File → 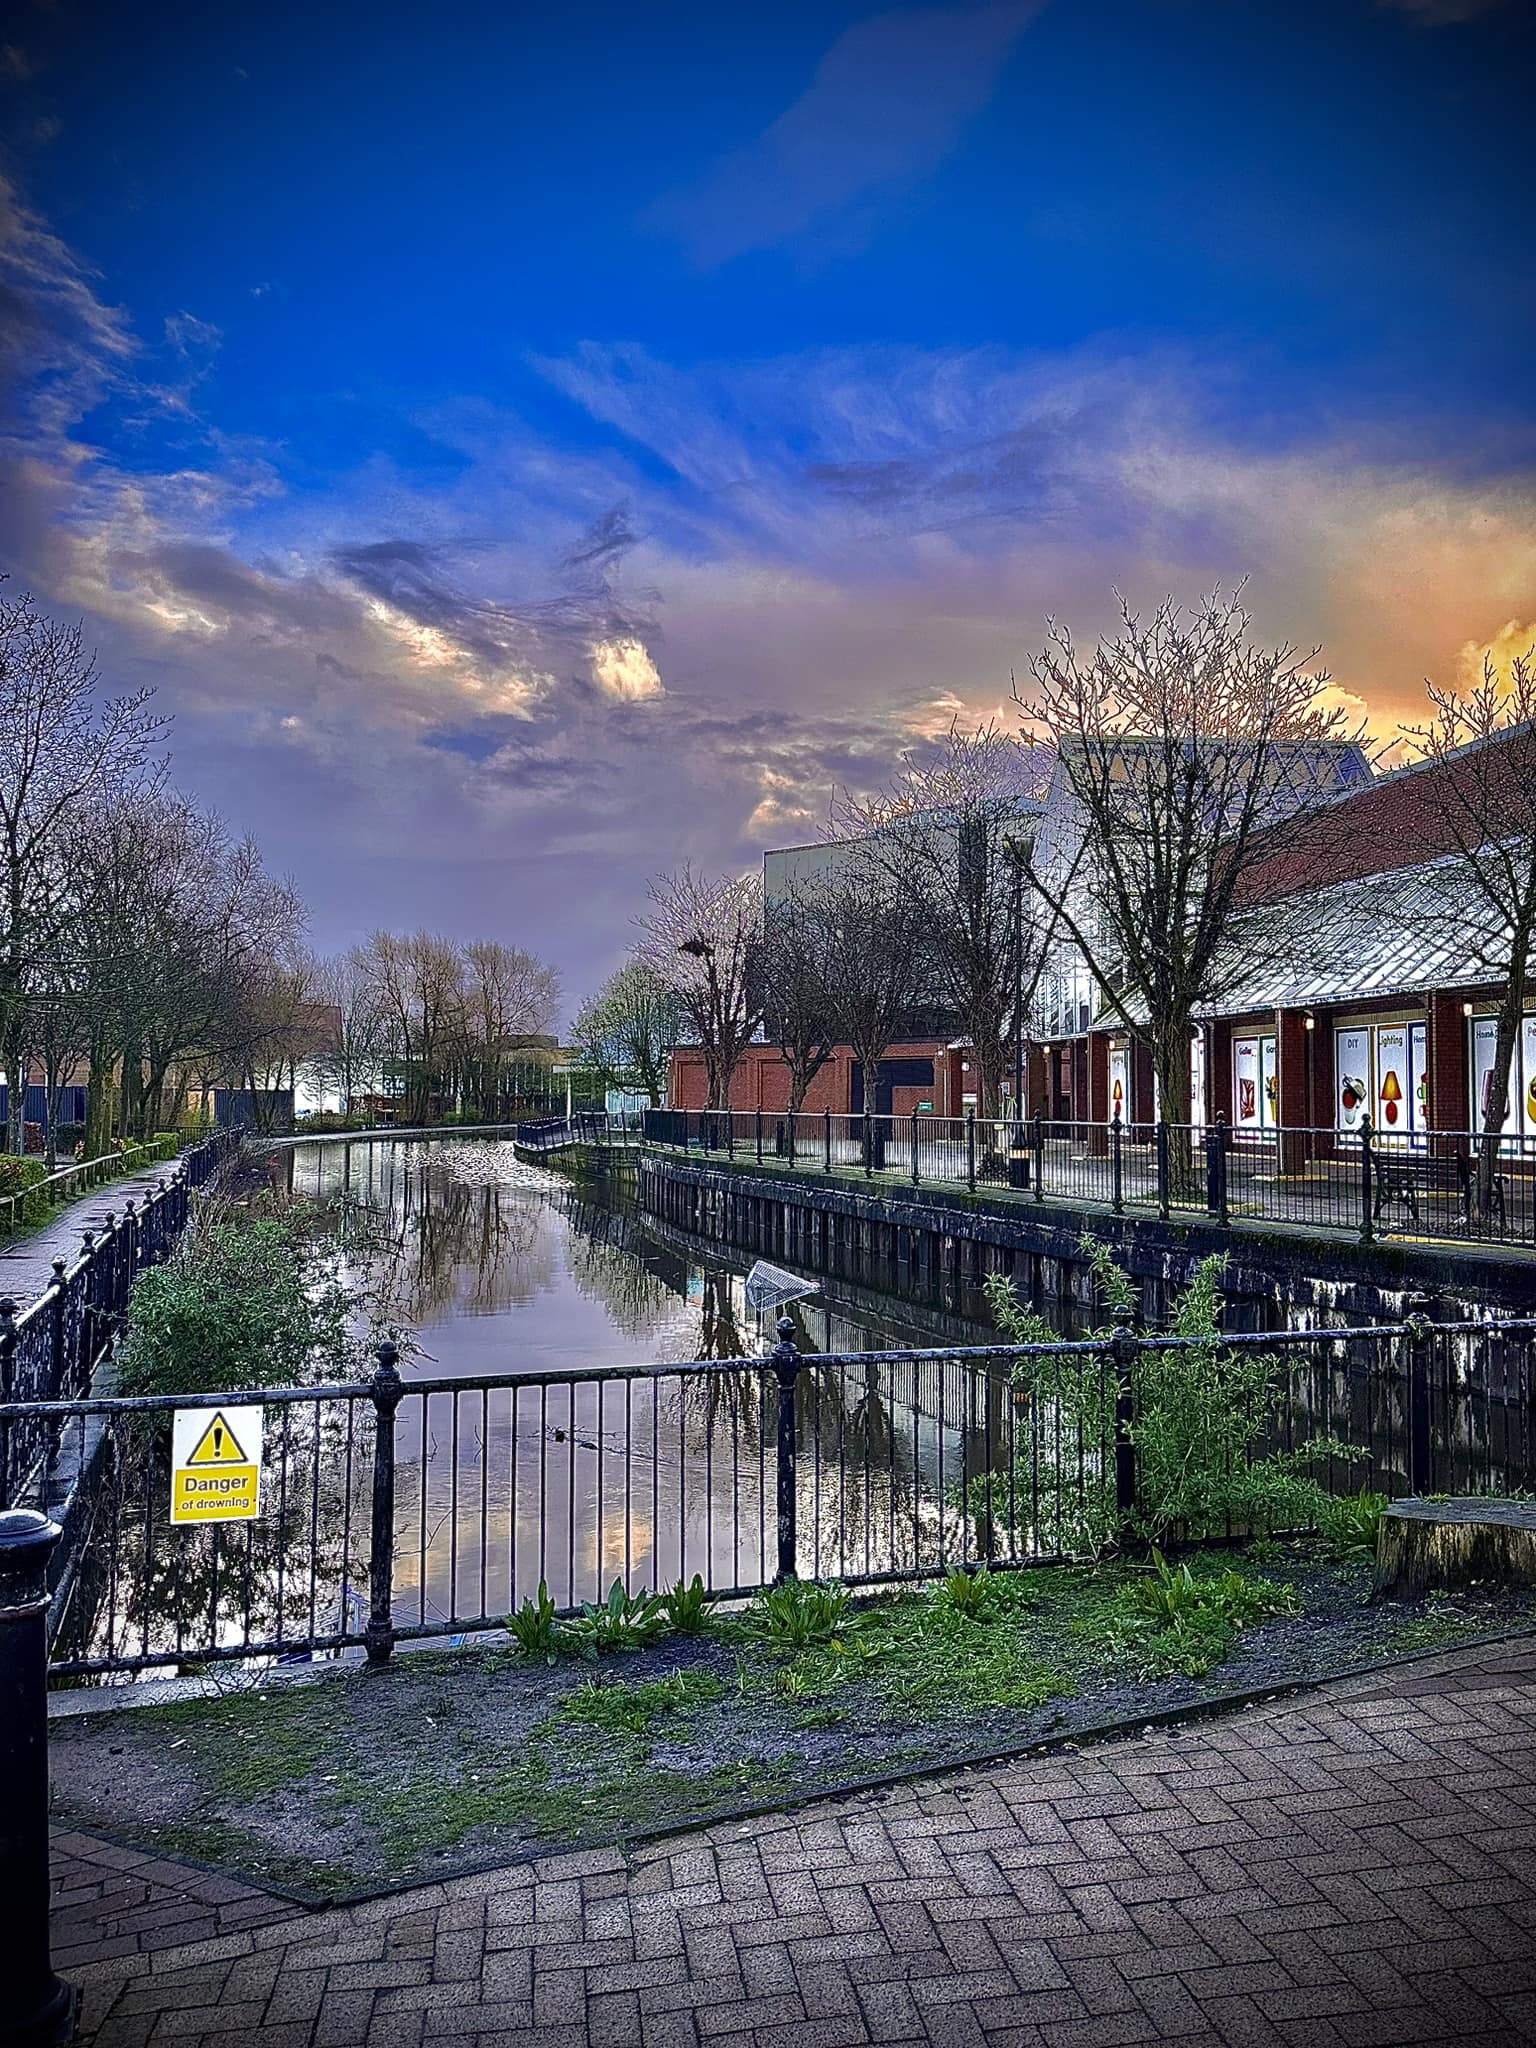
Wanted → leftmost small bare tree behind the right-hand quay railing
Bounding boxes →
[639,866,762,1110]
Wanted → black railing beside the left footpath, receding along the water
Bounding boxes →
[0,1130,240,1507]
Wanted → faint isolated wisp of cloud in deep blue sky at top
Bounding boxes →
[647,0,1042,266]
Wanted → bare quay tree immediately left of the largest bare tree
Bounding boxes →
[831,725,1051,1116]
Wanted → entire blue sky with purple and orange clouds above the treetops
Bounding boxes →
[0,0,1536,995]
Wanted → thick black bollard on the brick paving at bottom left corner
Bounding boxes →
[0,1507,76,2048]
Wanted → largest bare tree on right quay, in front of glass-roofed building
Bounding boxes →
[1018,590,1366,1171]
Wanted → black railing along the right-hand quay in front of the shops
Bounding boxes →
[643,1110,1536,1245]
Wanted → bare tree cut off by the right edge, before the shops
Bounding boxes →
[1405,643,1536,1219]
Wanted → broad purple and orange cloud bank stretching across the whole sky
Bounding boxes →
[0,174,1536,989]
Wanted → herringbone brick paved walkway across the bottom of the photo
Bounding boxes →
[55,1640,1536,2048]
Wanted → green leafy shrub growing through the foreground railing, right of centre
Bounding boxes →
[987,1235,1358,1554]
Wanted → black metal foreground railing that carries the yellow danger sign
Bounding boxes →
[12,1319,1536,1675]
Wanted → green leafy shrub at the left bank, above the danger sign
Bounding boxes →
[119,1202,369,1395]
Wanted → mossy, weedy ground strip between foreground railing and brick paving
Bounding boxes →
[53,1544,1536,1898]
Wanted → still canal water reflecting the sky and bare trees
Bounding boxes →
[279,1141,1028,1628]
